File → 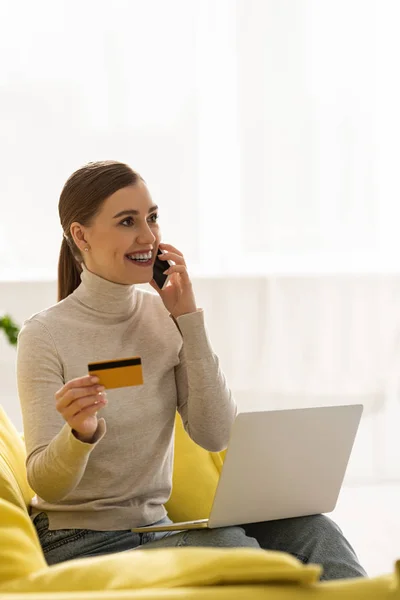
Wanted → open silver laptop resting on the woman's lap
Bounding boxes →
[132,404,363,532]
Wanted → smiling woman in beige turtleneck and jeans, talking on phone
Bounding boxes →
[17,161,365,579]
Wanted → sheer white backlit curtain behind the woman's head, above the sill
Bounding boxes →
[0,0,400,279]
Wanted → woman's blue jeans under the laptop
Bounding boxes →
[34,513,367,580]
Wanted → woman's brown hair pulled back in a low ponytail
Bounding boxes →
[58,160,142,301]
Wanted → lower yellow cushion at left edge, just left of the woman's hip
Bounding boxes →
[0,498,48,589]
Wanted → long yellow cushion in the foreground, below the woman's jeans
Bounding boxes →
[0,548,321,593]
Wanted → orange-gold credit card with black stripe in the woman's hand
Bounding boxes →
[88,356,143,389]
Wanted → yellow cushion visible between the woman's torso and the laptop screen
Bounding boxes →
[166,414,224,522]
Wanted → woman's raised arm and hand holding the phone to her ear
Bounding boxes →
[151,244,236,452]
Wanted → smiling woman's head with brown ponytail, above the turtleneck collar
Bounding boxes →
[58,161,161,300]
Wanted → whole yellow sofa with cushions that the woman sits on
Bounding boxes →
[0,407,400,600]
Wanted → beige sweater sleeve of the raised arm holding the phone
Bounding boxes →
[175,310,236,452]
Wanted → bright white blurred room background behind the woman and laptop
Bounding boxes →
[0,0,400,574]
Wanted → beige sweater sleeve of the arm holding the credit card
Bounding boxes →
[17,319,105,502]
